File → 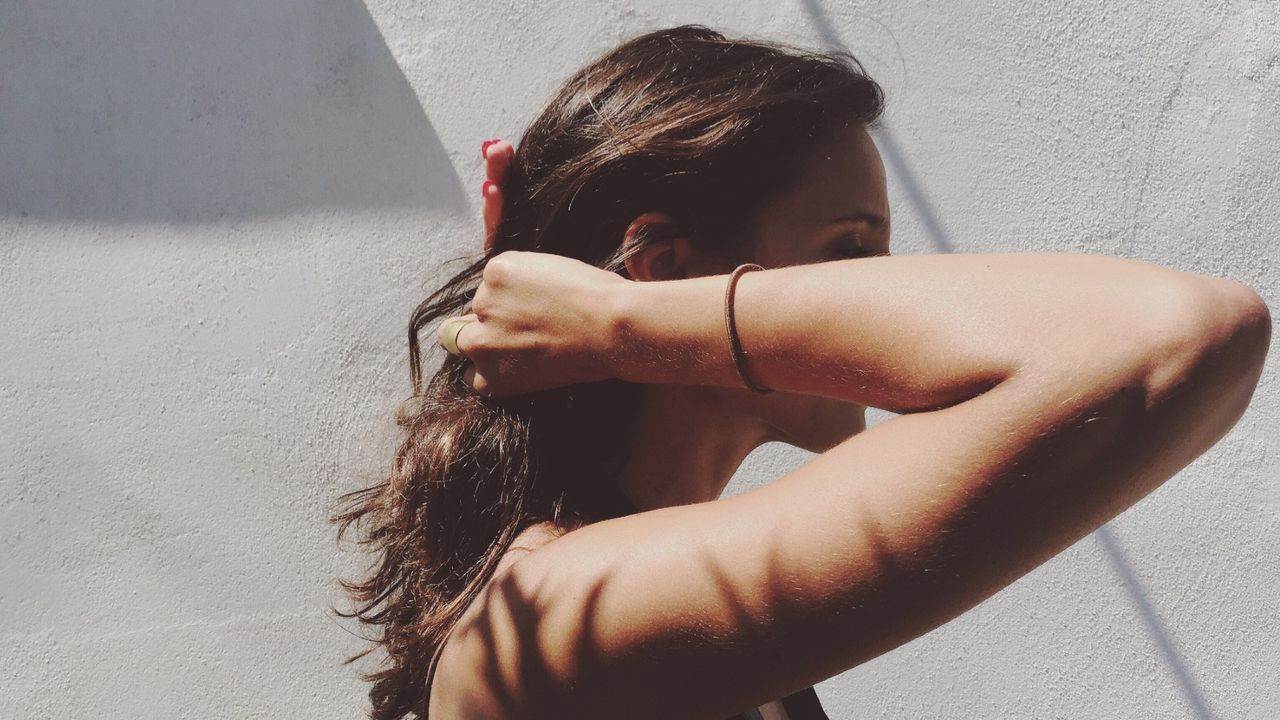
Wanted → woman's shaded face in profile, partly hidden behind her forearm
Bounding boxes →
[750,124,890,452]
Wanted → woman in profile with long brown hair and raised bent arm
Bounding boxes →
[335,26,1271,720]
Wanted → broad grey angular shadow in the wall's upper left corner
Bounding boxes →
[0,0,465,223]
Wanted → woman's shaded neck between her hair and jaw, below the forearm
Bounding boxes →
[617,386,768,511]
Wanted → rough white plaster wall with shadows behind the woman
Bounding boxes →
[0,0,1280,720]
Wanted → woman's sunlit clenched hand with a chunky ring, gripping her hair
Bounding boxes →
[436,250,631,396]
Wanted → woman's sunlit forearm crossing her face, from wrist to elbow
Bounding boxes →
[611,252,1239,413]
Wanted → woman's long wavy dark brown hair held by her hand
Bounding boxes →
[332,26,883,720]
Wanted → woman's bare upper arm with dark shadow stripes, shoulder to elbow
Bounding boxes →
[445,275,1264,720]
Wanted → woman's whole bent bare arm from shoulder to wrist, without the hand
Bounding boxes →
[447,252,1271,719]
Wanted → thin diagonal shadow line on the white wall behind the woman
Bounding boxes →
[800,0,1213,720]
